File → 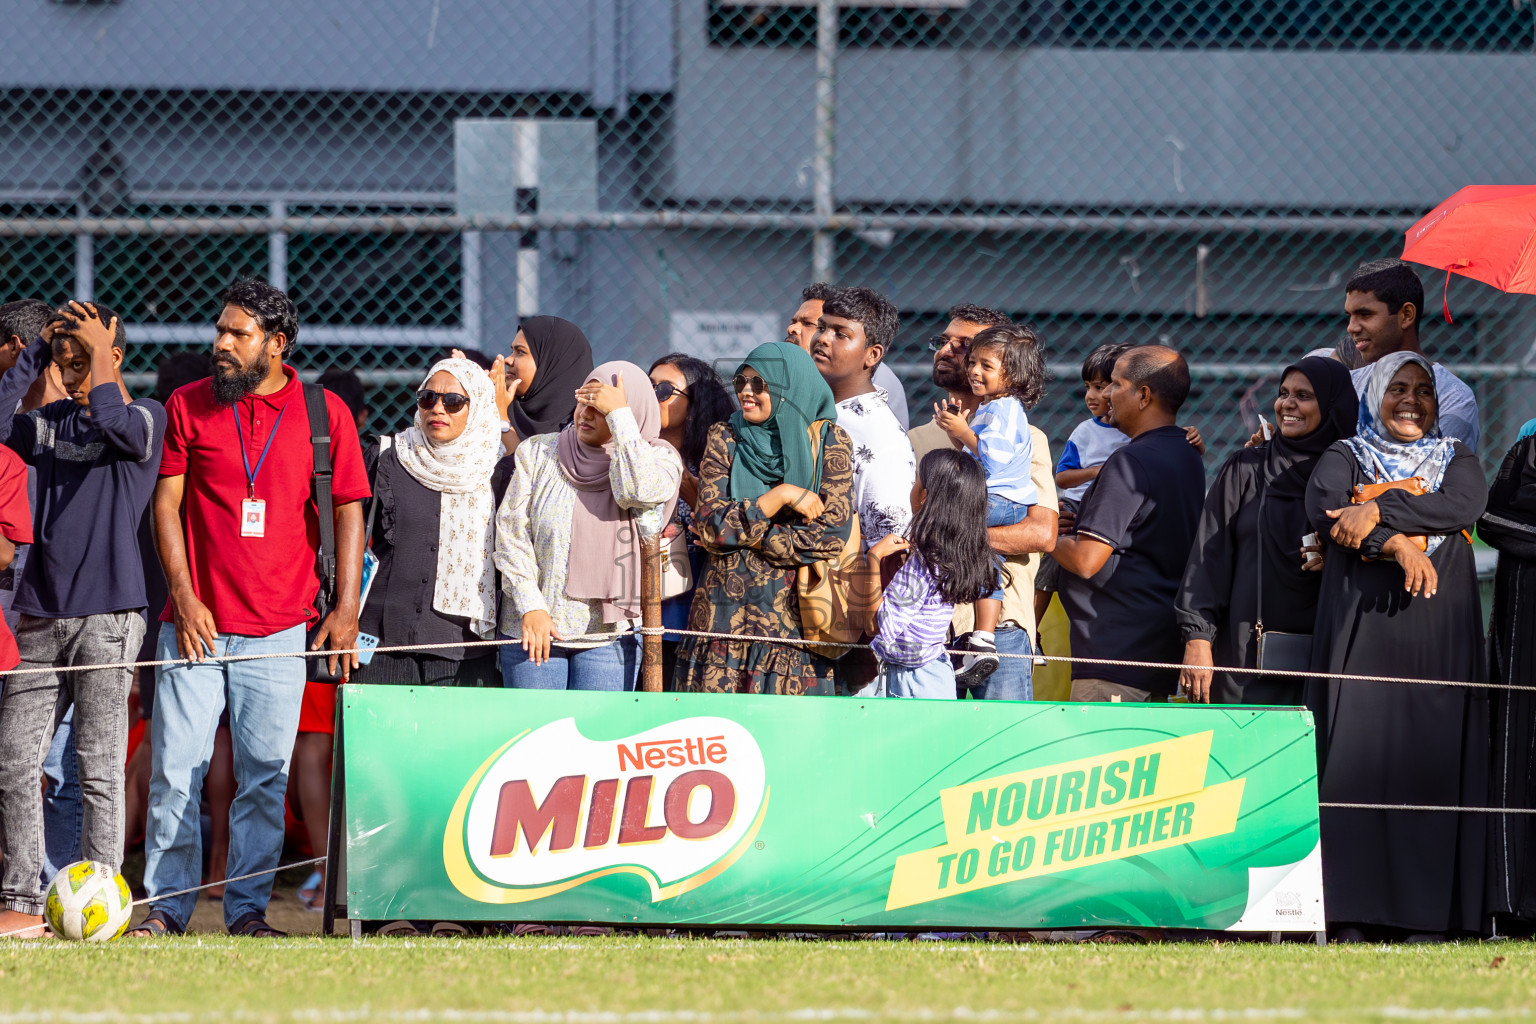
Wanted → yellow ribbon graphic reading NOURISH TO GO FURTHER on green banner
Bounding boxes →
[885,732,1244,910]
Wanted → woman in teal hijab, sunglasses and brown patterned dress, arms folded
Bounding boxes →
[676,342,854,694]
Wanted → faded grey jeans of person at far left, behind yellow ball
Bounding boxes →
[0,611,144,913]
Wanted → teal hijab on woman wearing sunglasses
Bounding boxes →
[731,341,837,502]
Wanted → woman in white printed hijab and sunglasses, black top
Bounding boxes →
[356,359,501,686]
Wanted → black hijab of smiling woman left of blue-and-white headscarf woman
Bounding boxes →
[1260,356,1359,580]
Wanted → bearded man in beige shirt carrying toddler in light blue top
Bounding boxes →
[908,304,1058,700]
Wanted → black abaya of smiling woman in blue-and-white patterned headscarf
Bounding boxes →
[1307,442,1488,932]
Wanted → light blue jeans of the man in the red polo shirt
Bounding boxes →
[144,622,306,930]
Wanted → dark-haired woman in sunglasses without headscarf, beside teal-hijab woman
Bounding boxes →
[651,352,736,689]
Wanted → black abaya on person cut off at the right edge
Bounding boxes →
[1479,438,1536,920]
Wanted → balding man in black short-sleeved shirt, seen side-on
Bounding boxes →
[1055,345,1206,702]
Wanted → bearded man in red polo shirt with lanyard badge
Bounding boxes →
[129,279,369,935]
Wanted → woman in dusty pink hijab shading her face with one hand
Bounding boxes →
[496,362,682,689]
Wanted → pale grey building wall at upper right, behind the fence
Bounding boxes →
[674,3,1536,209]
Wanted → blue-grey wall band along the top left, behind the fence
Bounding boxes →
[0,0,673,106]
